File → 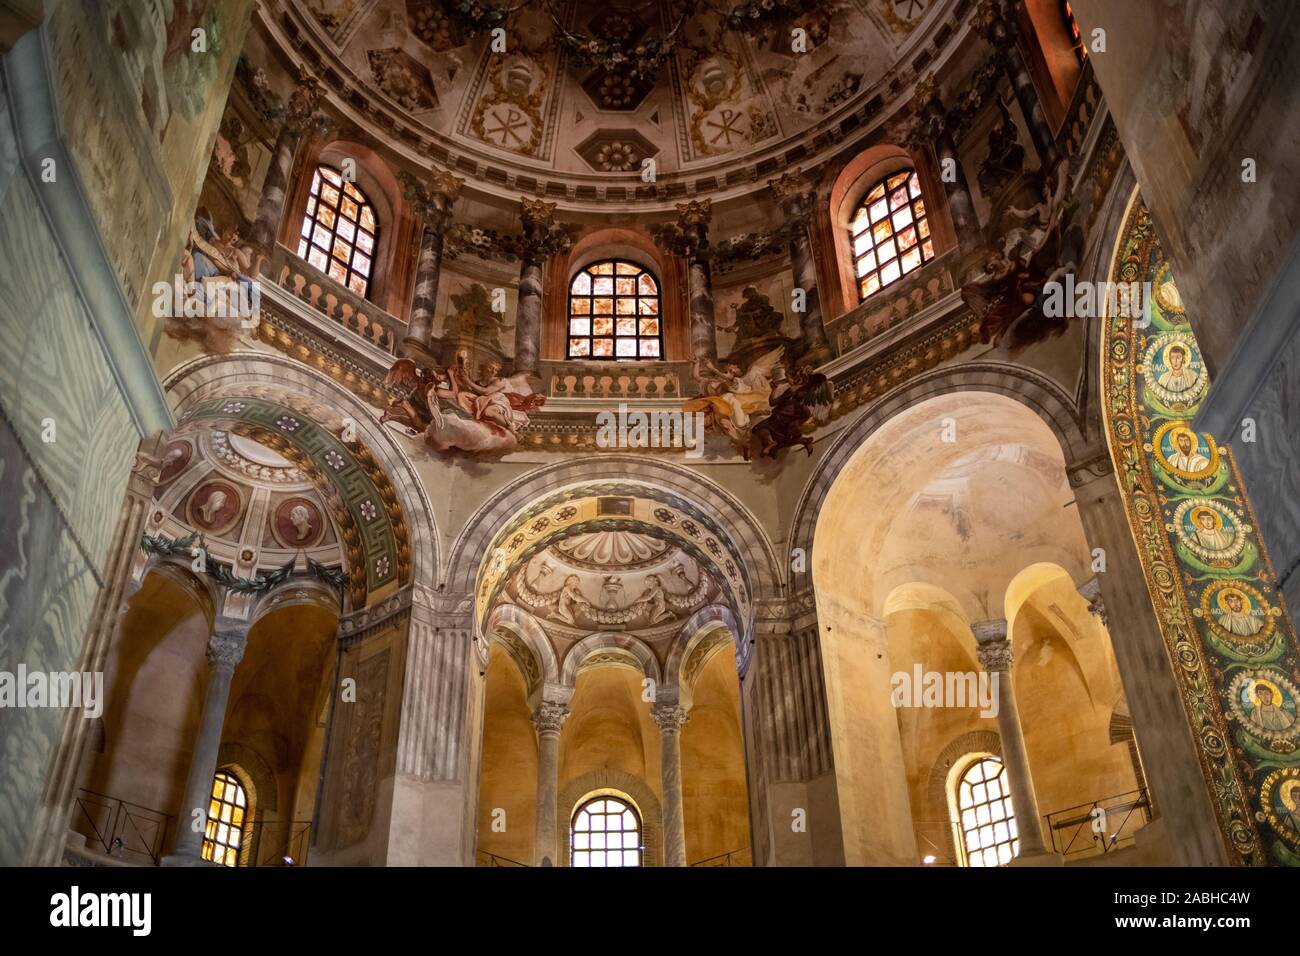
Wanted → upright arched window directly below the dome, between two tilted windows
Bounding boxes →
[566,259,663,362]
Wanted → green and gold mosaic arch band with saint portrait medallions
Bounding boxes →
[1102,194,1300,866]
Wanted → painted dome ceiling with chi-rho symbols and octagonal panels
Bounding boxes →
[268,0,953,198]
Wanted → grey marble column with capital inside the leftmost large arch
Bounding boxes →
[163,618,248,866]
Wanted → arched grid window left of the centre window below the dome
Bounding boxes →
[298,165,380,297]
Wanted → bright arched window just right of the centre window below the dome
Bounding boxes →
[849,169,935,302]
